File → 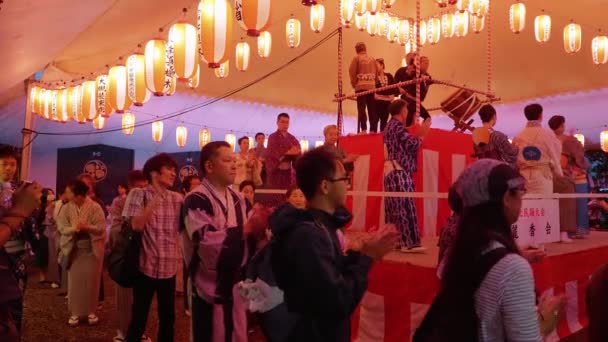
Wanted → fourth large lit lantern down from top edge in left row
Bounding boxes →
[144,39,173,96]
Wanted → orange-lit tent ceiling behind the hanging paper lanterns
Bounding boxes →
[0,0,608,113]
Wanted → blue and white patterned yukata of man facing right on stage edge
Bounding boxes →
[384,119,422,248]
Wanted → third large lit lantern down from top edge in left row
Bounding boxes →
[167,21,198,81]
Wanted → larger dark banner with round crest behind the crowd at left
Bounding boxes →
[57,145,135,205]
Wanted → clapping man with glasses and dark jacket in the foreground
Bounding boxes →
[270,148,398,342]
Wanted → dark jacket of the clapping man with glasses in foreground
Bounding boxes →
[270,206,372,342]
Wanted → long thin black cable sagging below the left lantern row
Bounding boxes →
[24,28,339,136]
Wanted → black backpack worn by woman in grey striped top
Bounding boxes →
[412,247,510,342]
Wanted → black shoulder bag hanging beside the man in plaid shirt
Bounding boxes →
[105,194,146,288]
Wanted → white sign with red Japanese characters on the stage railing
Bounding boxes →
[511,199,560,246]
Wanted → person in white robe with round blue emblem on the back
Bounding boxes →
[513,103,563,194]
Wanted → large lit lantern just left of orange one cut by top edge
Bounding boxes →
[197,0,232,68]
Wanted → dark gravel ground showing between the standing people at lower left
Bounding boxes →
[22,271,264,342]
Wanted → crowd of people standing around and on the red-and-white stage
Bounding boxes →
[0,48,606,342]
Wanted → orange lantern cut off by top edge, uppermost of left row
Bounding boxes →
[234,0,272,37]
